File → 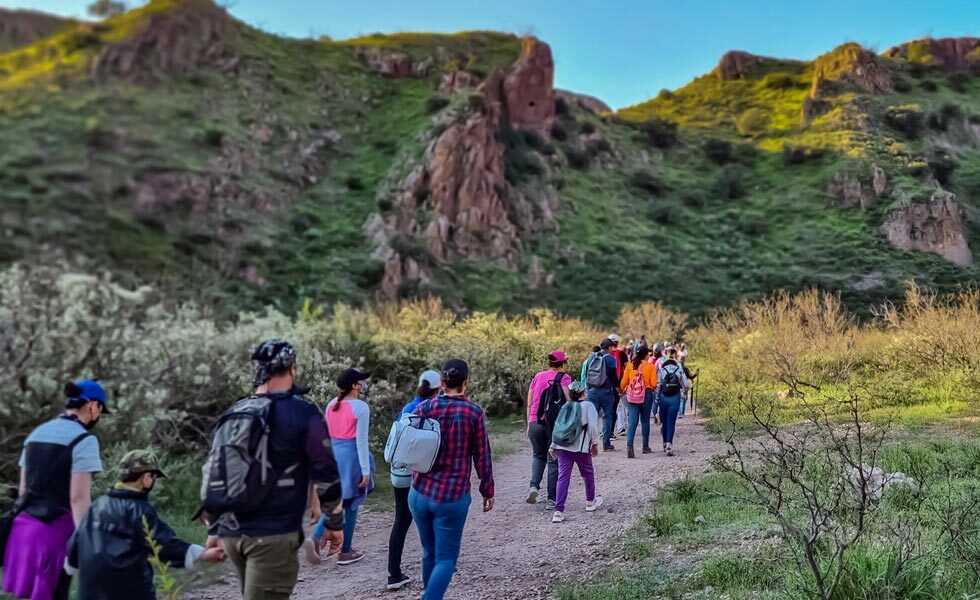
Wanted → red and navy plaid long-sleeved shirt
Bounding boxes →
[414,394,493,503]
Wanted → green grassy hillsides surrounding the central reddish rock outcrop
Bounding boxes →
[0,0,980,322]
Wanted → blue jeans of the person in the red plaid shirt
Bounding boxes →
[408,488,470,600]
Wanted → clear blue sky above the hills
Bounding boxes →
[9,0,980,108]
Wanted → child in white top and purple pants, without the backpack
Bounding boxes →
[551,381,602,523]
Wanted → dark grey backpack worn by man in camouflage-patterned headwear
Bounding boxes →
[201,396,290,516]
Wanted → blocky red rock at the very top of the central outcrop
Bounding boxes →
[502,38,555,137]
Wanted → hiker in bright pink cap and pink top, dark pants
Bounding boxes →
[525,350,572,511]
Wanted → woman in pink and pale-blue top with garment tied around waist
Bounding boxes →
[326,369,375,565]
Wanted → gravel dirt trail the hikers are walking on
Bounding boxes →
[194,415,721,600]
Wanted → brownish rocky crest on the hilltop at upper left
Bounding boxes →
[92,0,238,80]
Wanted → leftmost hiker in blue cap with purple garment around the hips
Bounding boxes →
[3,379,109,600]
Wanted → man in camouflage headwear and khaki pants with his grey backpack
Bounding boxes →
[201,340,343,600]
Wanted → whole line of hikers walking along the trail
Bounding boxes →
[0,334,692,600]
